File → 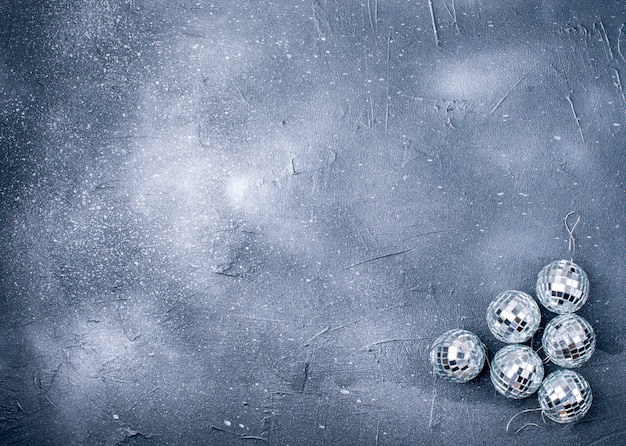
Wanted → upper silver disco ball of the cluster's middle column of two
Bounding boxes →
[487,290,541,344]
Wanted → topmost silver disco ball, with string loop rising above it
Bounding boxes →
[536,260,589,314]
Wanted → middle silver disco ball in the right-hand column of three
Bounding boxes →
[542,314,596,368]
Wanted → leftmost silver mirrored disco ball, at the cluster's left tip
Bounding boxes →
[430,329,487,383]
